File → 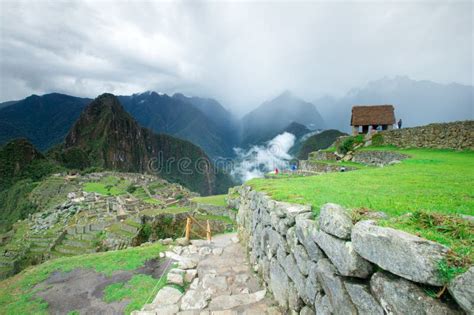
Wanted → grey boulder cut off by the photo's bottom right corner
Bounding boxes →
[448,267,474,315]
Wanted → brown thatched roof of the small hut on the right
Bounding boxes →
[351,105,395,126]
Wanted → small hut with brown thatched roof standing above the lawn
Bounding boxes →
[351,105,395,135]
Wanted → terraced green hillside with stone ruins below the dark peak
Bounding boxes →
[0,173,196,277]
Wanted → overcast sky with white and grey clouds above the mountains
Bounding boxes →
[0,0,473,113]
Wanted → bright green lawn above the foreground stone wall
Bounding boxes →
[247,148,474,260]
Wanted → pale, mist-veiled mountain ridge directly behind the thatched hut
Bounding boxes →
[313,76,474,131]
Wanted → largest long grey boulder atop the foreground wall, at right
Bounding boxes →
[352,221,449,286]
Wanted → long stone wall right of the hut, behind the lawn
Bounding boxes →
[381,120,474,150]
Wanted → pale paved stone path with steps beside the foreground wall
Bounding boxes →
[132,233,282,315]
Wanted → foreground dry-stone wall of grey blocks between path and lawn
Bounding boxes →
[228,186,474,314]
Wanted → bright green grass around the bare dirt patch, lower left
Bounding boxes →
[0,244,165,314]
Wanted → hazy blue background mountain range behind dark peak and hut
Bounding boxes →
[0,76,474,159]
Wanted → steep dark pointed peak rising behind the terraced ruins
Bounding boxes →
[60,93,227,194]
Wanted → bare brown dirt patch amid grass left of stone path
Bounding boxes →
[35,260,168,315]
